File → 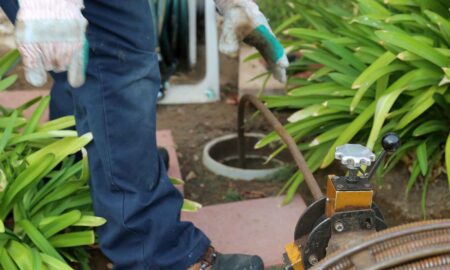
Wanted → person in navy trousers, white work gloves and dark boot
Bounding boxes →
[0,0,288,270]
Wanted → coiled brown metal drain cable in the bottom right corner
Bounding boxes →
[312,219,450,270]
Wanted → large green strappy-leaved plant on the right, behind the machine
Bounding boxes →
[256,0,450,210]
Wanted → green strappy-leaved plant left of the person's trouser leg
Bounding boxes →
[0,51,105,270]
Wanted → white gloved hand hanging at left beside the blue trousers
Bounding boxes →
[16,0,88,87]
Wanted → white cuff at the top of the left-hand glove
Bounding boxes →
[19,0,84,19]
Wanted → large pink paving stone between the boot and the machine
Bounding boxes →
[182,196,306,267]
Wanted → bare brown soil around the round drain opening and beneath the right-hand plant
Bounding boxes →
[158,99,450,225]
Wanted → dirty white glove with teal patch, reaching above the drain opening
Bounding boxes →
[215,0,289,83]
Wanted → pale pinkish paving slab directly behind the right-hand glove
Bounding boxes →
[238,45,285,96]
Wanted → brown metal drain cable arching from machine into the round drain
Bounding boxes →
[238,95,324,200]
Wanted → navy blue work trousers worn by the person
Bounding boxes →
[0,0,210,270]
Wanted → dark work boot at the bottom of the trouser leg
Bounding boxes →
[190,247,264,270]
